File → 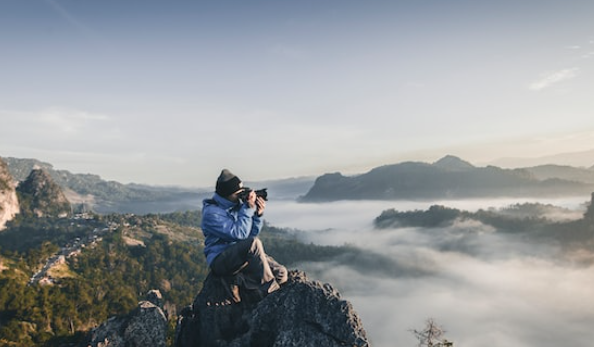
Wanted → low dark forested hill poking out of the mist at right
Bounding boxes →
[374,193,594,250]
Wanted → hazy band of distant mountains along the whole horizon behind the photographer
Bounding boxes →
[4,155,594,209]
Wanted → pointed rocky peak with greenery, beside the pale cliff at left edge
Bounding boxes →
[17,169,70,217]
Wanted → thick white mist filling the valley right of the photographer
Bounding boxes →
[266,196,594,347]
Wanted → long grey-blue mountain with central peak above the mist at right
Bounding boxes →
[301,156,594,201]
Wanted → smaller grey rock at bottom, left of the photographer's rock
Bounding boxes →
[80,290,167,347]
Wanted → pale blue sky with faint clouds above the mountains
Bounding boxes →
[0,0,594,187]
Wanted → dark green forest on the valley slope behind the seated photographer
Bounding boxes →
[0,211,352,347]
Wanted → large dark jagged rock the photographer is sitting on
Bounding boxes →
[175,271,370,347]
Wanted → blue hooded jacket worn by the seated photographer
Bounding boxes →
[201,193,262,266]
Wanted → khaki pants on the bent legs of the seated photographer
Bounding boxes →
[210,237,287,293]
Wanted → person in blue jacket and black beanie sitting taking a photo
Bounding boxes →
[202,169,287,302]
